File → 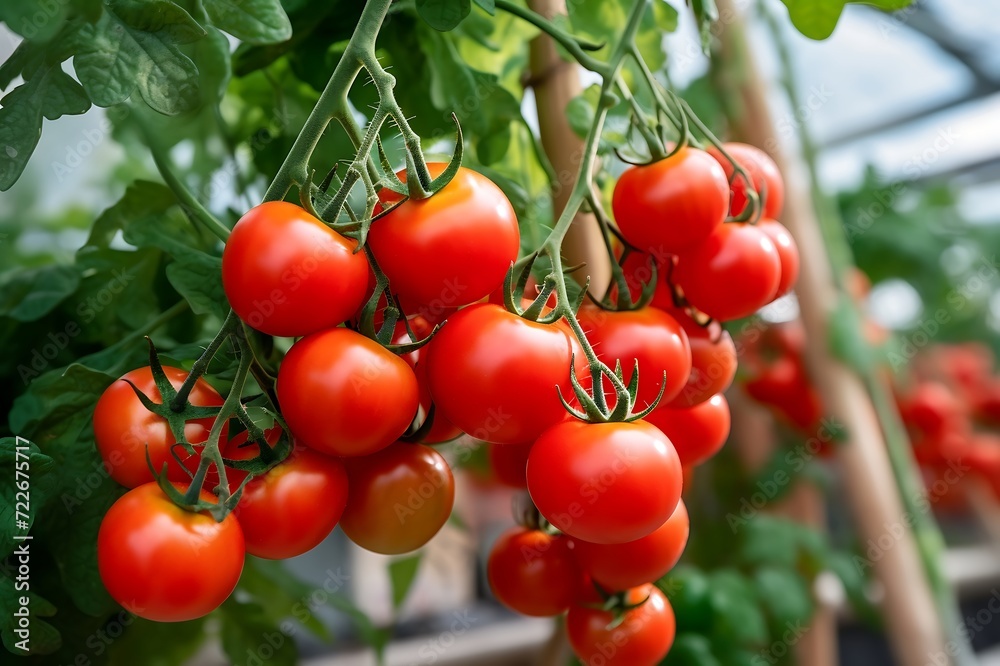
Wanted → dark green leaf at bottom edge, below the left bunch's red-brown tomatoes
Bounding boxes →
[218,596,299,666]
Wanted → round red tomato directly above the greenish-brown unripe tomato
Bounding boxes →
[277,328,419,456]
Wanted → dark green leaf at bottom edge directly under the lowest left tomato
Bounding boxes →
[108,617,207,666]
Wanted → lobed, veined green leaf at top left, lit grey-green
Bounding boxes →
[73,0,207,115]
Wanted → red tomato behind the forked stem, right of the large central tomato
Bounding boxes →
[577,305,691,411]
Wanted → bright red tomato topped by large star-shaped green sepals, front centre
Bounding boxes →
[527,421,683,543]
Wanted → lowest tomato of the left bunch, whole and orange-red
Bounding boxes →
[97,483,245,622]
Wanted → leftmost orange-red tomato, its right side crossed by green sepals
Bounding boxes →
[94,366,227,488]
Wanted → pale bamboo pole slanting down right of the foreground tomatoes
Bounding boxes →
[718,0,950,666]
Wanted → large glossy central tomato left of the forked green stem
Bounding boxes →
[427,303,590,444]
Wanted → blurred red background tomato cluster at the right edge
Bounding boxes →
[897,343,1000,506]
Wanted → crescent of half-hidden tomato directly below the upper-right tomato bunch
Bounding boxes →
[664,317,737,409]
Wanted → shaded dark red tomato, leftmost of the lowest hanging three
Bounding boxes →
[486,527,583,617]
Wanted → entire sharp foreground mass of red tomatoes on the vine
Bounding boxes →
[94,144,798,648]
